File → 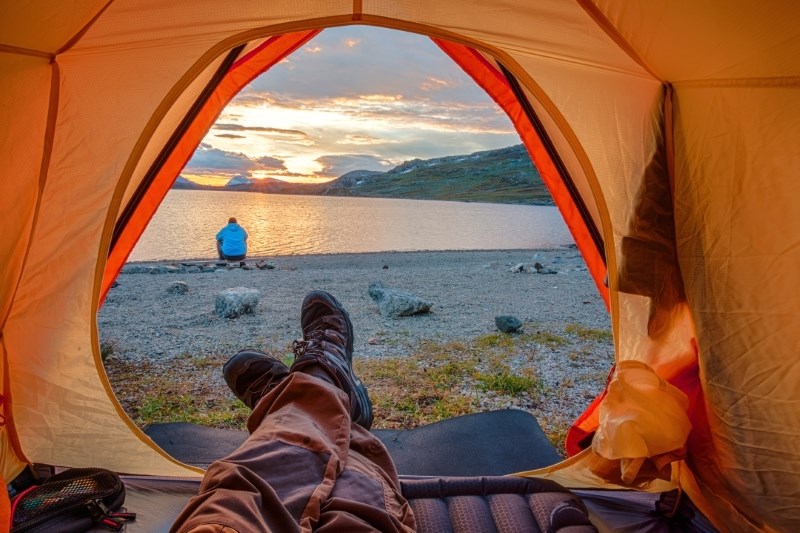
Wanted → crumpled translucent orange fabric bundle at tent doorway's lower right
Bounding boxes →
[591,361,692,485]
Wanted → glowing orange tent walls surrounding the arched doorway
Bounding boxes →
[0,0,800,530]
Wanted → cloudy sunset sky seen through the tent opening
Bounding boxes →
[182,26,520,185]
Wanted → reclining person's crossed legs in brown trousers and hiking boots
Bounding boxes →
[173,293,414,532]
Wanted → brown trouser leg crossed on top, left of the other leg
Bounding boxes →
[173,372,350,533]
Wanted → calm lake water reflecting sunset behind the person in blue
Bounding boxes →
[130,190,573,261]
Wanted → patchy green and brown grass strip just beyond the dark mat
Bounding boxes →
[101,324,611,449]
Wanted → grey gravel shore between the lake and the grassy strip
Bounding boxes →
[98,248,613,440]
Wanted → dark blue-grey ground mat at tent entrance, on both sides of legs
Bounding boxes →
[145,409,561,476]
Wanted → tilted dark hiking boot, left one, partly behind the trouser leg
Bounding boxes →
[222,350,289,409]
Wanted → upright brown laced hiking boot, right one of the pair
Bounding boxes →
[291,291,372,429]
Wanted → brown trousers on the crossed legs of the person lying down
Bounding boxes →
[172,372,415,533]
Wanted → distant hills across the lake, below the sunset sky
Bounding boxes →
[174,144,553,205]
